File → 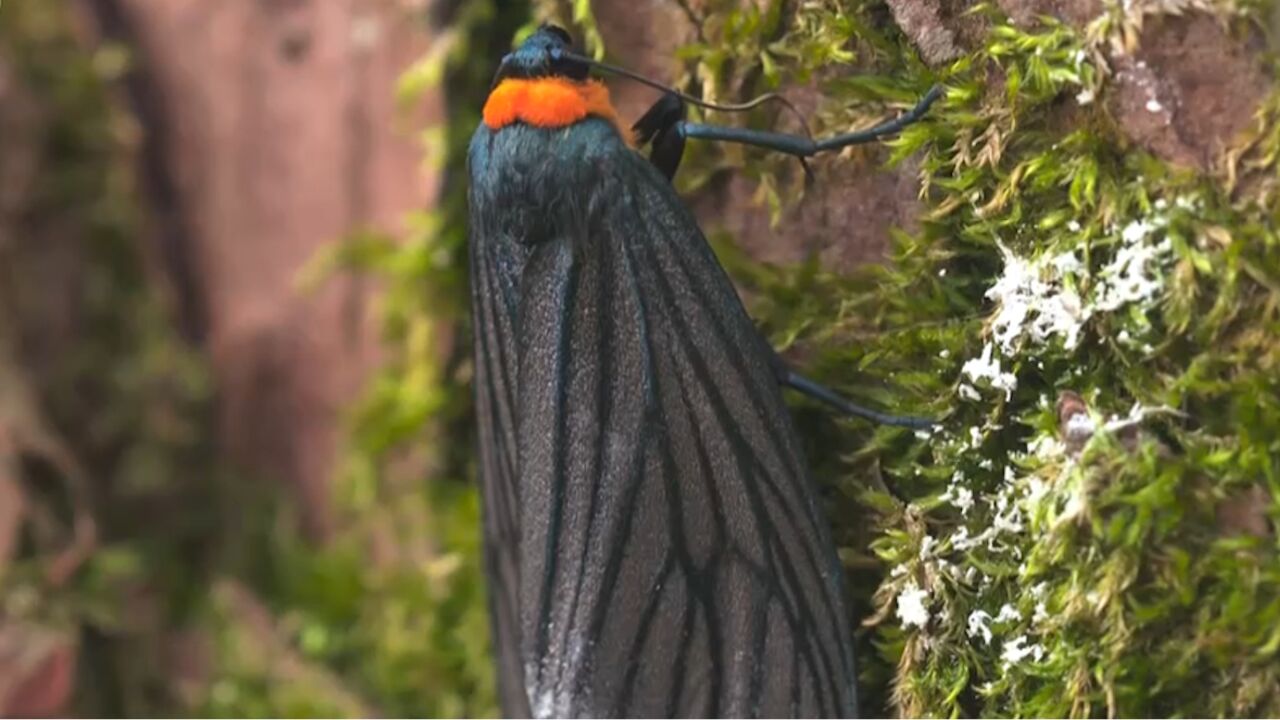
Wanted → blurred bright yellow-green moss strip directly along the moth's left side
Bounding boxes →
[249,0,529,717]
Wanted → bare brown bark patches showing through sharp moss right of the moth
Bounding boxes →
[593,0,1270,270]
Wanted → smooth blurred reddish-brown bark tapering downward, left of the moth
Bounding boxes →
[90,0,440,537]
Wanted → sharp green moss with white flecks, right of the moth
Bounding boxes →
[524,1,1280,716]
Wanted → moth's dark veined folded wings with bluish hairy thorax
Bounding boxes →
[470,114,856,716]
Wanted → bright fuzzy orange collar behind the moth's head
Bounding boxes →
[484,77,632,145]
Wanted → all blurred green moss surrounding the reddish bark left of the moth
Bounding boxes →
[0,1,526,716]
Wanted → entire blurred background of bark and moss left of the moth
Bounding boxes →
[0,0,529,716]
